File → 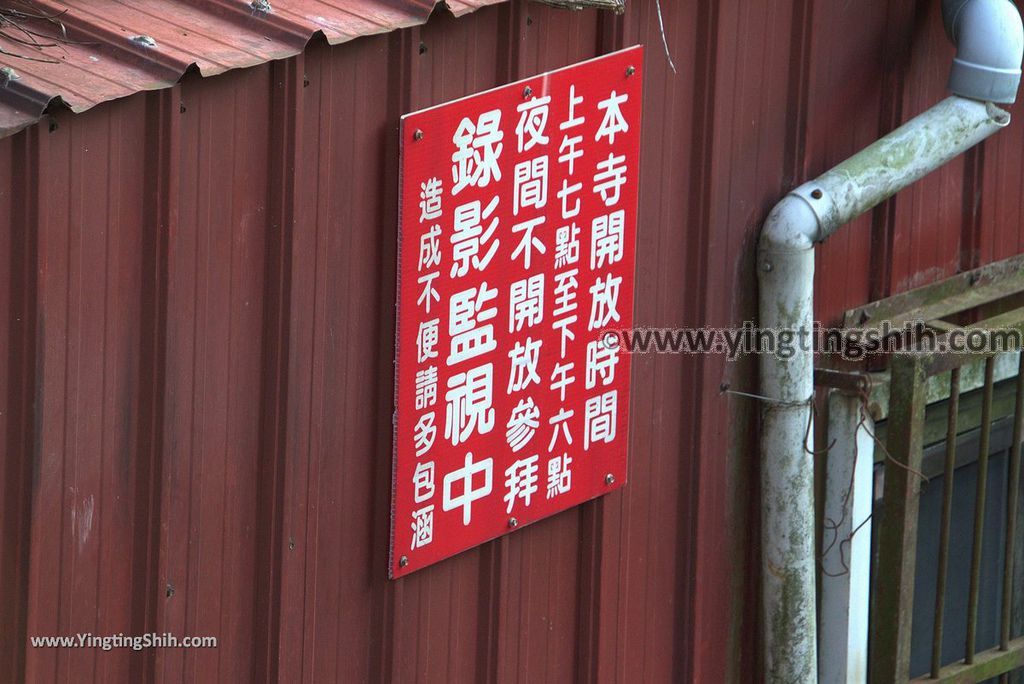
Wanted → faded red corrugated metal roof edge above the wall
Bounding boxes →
[0,0,503,135]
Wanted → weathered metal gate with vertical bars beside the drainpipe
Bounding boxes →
[822,257,1024,682]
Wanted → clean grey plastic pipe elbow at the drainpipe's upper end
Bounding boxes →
[942,0,1024,103]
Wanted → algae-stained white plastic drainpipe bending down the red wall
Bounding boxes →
[757,0,1024,684]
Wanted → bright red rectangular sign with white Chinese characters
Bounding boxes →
[389,47,643,578]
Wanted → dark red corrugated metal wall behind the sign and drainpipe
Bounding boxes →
[0,0,1024,683]
